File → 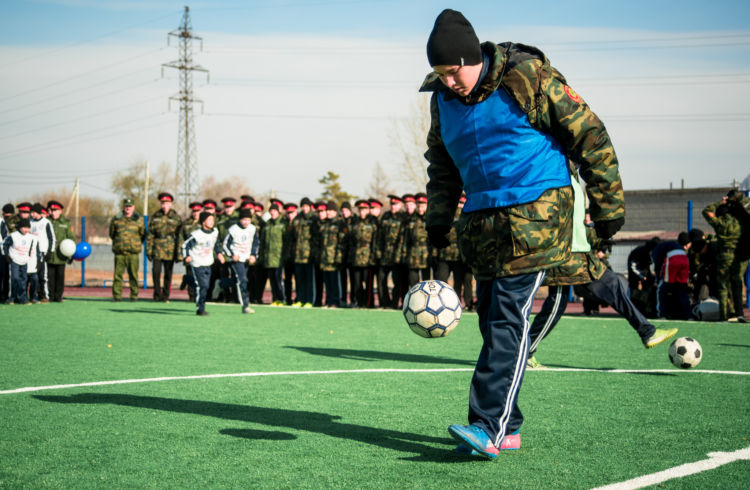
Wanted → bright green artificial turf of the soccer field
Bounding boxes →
[0,299,750,488]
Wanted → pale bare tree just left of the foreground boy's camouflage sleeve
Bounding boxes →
[390,94,430,191]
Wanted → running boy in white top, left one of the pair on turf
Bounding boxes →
[182,211,224,316]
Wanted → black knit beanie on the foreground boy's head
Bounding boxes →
[427,9,482,66]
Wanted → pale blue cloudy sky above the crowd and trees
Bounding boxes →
[0,0,750,202]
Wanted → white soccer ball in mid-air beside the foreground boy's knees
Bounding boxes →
[403,280,461,339]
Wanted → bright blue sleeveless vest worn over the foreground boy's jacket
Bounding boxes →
[437,88,570,212]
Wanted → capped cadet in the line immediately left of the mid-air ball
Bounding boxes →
[376,195,404,309]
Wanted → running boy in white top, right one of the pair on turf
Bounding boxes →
[222,209,260,313]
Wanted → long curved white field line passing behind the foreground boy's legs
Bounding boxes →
[0,368,750,395]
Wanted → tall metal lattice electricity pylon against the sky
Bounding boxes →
[162,6,208,203]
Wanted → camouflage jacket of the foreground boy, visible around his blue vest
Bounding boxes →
[420,43,625,279]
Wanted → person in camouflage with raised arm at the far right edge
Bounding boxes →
[703,189,750,323]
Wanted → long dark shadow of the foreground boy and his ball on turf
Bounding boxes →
[32,393,476,462]
